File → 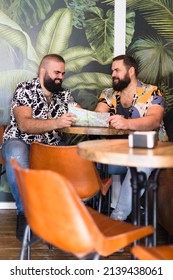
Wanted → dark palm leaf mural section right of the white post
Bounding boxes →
[125,0,173,110]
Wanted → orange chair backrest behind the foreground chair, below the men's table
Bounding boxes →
[30,142,102,200]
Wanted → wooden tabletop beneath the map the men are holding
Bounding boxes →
[60,126,129,135]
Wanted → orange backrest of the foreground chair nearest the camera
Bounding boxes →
[11,158,102,257]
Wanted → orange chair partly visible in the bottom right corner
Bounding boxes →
[131,245,173,260]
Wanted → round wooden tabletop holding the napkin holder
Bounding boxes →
[77,139,173,168]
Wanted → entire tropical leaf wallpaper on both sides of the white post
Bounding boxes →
[0,0,173,200]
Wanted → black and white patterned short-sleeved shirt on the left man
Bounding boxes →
[3,78,72,146]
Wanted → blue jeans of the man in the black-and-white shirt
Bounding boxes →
[2,138,30,214]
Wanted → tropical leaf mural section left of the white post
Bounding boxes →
[0,0,114,201]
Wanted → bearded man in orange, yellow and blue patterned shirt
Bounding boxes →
[95,55,168,220]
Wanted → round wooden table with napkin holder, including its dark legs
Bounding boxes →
[77,139,173,246]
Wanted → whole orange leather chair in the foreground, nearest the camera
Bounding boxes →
[11,159,154,259]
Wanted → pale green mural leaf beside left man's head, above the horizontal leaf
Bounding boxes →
[61,46,96,72]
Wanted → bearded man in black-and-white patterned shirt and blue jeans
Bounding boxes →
[2,54,78,240]
